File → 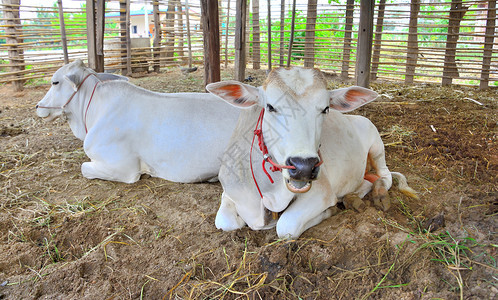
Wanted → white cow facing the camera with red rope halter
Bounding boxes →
[207,68,414,238]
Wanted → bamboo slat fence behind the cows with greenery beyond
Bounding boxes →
[0,0,498,88]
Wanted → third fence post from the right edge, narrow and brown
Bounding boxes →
[405,0,420,84]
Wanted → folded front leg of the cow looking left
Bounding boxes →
[81,161,140,183]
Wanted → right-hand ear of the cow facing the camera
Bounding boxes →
[329,86,379,112]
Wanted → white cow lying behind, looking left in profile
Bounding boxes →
[37,60,239,183]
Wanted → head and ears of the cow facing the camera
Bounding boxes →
[206,67,377,193]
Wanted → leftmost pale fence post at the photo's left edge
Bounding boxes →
[3,0,25,92]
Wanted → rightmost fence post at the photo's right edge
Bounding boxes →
[479,0,496,90]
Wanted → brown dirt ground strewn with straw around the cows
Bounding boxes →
[0,69,498,299]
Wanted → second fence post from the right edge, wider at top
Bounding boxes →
[441,0,469,86]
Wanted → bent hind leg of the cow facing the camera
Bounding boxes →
[368,136,392,211]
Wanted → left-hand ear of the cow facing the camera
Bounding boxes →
[206,81,259,108]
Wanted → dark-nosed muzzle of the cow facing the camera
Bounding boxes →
[285,156,321,193]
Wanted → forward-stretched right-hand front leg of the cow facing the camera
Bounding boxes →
[277,192,337,239]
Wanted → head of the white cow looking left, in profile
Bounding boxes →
[36,59,94,120]
